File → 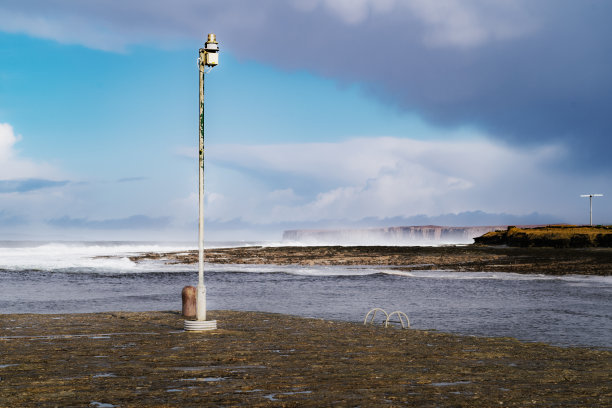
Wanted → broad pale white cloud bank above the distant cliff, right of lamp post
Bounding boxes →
[208,137,568,223]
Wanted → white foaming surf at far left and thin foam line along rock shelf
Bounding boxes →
[0,242,612,287]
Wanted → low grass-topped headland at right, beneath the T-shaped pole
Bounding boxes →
[474,225,612,248]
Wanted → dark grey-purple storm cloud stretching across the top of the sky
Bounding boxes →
[0,0,612,167]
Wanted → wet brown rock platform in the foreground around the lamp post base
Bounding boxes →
[0,311,612,407]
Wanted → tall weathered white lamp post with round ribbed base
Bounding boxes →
[185,34,219,331]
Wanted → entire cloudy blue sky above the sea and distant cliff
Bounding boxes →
[0,0,612,241]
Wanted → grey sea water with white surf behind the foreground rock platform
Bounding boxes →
[0,242,612,349]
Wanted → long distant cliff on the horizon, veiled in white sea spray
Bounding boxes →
[283,225,520,245]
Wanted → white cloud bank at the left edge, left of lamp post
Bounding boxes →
[0,123,172,238]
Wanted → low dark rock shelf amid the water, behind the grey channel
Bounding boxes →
[130,245,612,275]
